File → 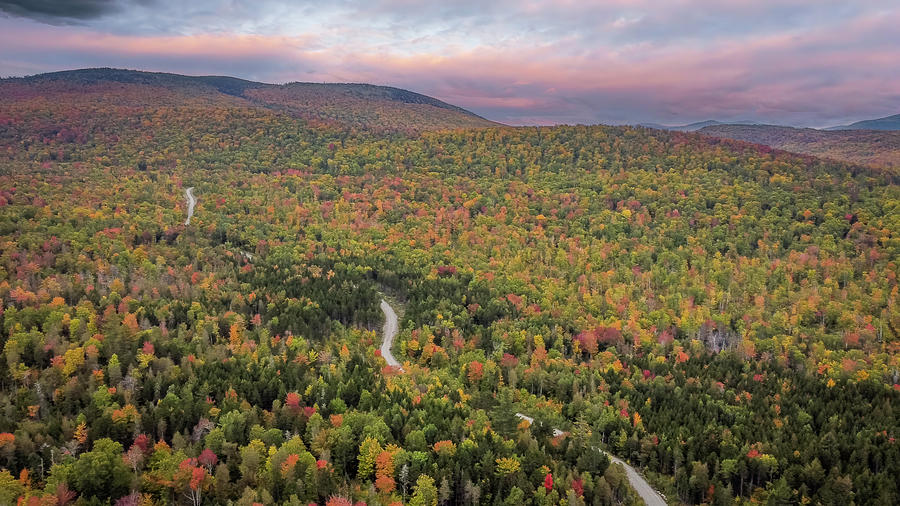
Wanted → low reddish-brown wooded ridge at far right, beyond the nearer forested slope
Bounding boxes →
[698,125,900,168]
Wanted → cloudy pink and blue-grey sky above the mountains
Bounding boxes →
[0,0,900,127]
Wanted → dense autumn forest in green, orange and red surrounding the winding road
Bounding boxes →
[0,70,900,506]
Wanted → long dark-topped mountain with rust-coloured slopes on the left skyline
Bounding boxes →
[0,68,498,132]
